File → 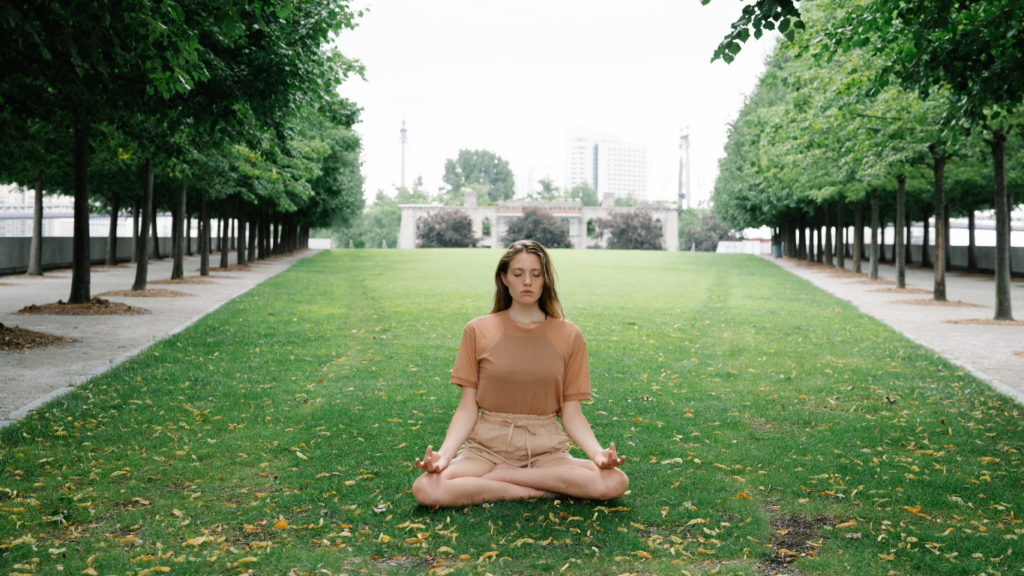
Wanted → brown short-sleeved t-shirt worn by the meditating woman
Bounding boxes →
[452,311,590,416]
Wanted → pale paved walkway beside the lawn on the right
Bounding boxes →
[768,258,1024,404]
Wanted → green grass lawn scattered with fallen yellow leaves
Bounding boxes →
[0,250,1024,576]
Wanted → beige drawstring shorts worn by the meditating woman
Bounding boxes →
[458,409,572,468]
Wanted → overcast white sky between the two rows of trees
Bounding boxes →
[338,0,774,201]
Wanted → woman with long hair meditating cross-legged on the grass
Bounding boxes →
[413,240,629,507]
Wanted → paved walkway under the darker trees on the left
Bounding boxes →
[0,250,317,427]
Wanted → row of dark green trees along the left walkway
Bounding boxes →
[0,0,364,303]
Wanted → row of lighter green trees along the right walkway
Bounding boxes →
[703,0,1024,320]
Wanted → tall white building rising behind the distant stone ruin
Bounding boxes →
[565,129,647,200]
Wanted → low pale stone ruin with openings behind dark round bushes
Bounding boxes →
[398,191,679,252]
